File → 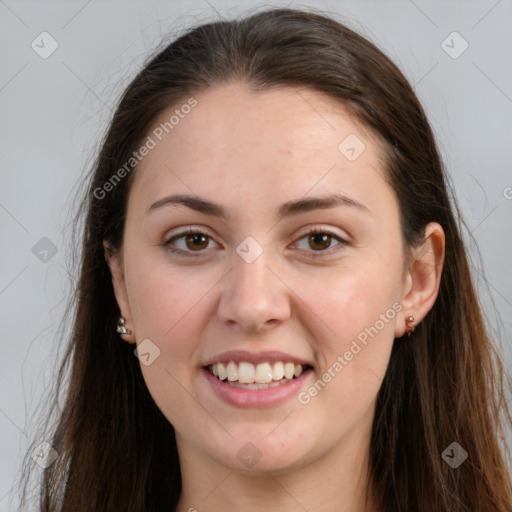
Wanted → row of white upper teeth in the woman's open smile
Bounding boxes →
[209,361,304,389]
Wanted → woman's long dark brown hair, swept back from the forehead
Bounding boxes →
[18,5,512,512]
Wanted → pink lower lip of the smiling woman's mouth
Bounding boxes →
[202,368,313,408]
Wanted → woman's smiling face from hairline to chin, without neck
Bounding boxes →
[110,83,412,472]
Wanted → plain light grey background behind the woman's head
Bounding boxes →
[0,0,512,510]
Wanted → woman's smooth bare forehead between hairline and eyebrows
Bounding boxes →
[128,83,383,212]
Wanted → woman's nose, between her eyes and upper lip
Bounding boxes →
[217,252,291,332]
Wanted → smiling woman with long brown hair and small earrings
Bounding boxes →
[19,9,512,512]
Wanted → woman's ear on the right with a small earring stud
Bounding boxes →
[395,222,445,338]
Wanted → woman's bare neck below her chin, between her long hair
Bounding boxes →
[176,418,378,512]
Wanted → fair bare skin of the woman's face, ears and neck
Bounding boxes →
[105,83,444,512]
